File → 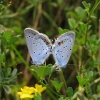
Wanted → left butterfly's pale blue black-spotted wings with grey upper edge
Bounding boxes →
[24,28,51,65]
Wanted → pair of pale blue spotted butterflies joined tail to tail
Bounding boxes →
[24,28,75,68]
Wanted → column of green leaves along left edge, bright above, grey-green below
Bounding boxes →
[0,22,20,98]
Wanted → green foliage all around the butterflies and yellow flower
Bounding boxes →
[0,0,100,100]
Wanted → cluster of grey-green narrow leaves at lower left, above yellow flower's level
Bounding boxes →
[0,68,18,94]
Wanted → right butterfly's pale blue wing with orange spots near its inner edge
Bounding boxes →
[52,32,75,67]
